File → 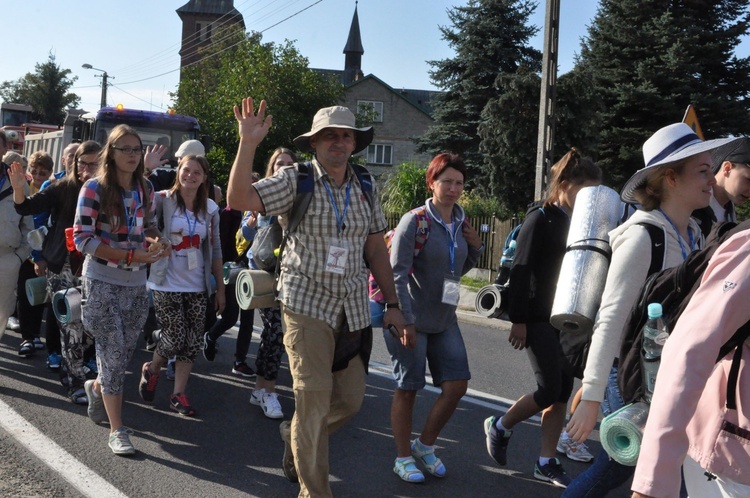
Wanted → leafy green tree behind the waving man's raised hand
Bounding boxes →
[173,29,343,185]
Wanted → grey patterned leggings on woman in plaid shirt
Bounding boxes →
[81,276,148,395]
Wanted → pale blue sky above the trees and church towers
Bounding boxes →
[0,0,750,115]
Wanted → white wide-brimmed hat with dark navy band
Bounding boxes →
[620,123,734,203]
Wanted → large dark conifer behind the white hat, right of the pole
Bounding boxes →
[570,0,750,187]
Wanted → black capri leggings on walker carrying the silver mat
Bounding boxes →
[526,322,573,409]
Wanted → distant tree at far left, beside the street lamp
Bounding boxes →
[0,52,81,125]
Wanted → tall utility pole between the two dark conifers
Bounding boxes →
[534,0,560,201]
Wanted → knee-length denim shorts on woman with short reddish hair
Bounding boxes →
[383,323,471,391]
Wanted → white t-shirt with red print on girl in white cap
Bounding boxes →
[149,209,208,292]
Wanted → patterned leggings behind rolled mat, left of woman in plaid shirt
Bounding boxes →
[47,263,94,390]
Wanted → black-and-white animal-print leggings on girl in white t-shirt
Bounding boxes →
[153,290,208,363]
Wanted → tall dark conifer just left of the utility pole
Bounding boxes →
[417,0,541,183]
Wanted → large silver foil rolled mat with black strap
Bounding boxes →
[550,186,621,332]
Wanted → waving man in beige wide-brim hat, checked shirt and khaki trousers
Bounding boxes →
[227,98,405,497]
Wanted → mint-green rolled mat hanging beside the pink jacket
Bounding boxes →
[599,402,648,467]
